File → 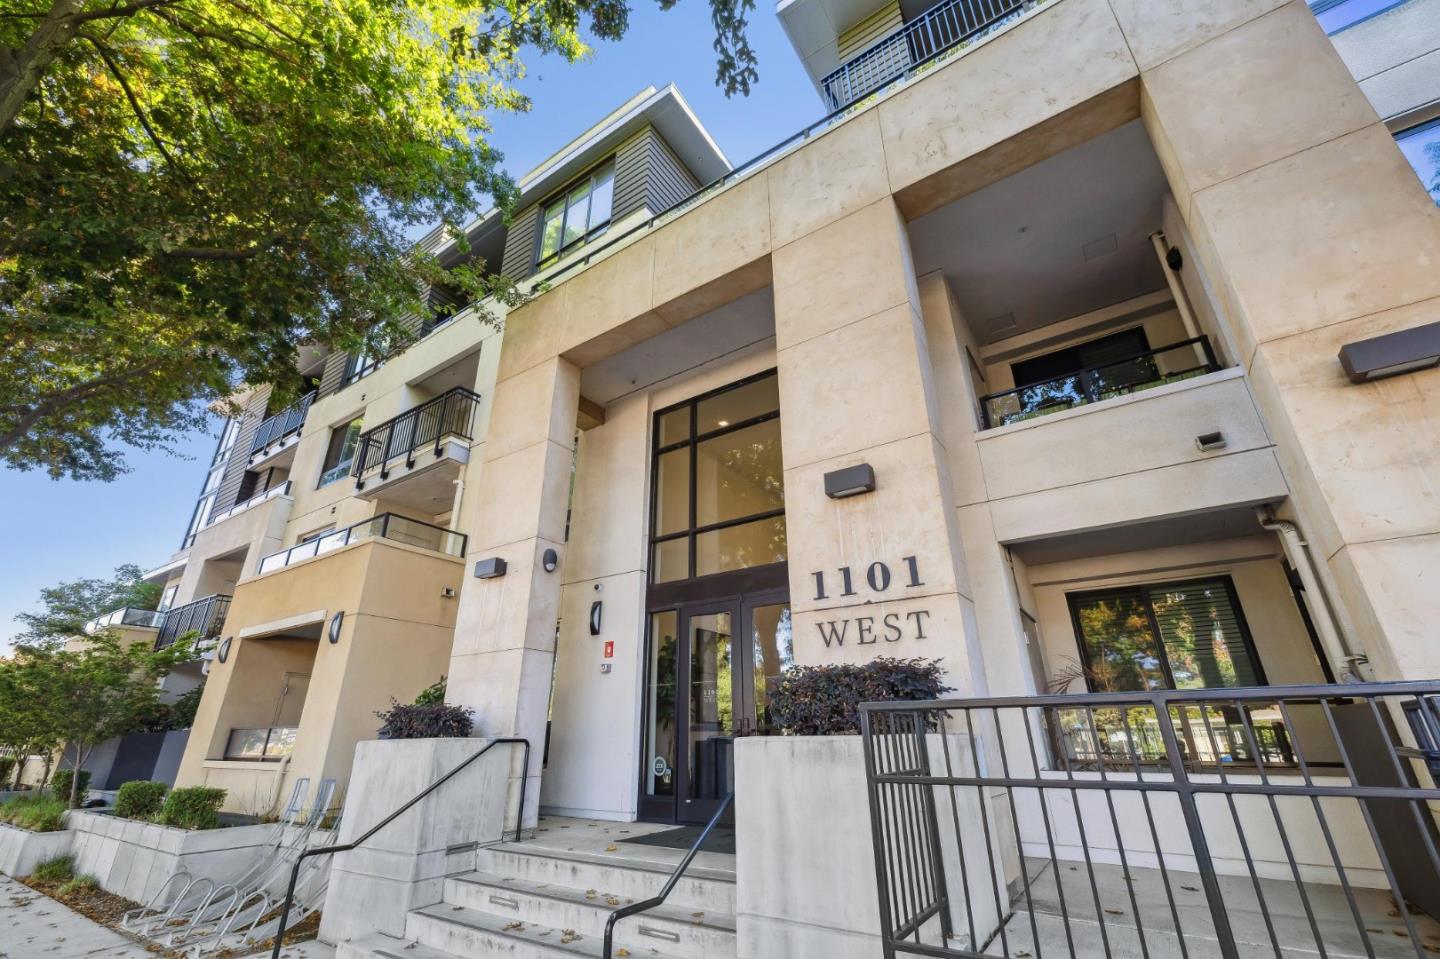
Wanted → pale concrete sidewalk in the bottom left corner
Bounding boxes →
[0,875,336,959]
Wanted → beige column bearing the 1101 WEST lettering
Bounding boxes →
[773,197,985,695]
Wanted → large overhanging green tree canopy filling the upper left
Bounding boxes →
[0,0,756,480]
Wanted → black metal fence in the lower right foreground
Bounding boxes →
[861,683,1440,959]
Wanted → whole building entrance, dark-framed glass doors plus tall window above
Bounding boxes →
[639,372,792,822]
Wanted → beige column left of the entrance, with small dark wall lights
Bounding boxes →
[446,357,580,822]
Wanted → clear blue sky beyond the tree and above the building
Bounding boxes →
[0,0,825,652]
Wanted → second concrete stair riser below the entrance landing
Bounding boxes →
[445,880,736,959]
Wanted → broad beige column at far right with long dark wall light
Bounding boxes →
[1134,3,1440,680]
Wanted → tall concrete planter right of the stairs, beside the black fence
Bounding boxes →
[734,736,996,959]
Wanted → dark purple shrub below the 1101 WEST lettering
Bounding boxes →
[770,657,950,736]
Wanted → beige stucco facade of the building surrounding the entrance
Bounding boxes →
[151,0,1440,819]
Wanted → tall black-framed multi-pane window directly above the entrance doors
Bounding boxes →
[649,372,786,583]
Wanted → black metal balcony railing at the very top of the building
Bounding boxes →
[821,0,1028,109]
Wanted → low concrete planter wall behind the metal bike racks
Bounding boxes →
[69,811,306,903]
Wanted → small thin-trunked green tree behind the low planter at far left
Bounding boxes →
[0,634,193,805]
